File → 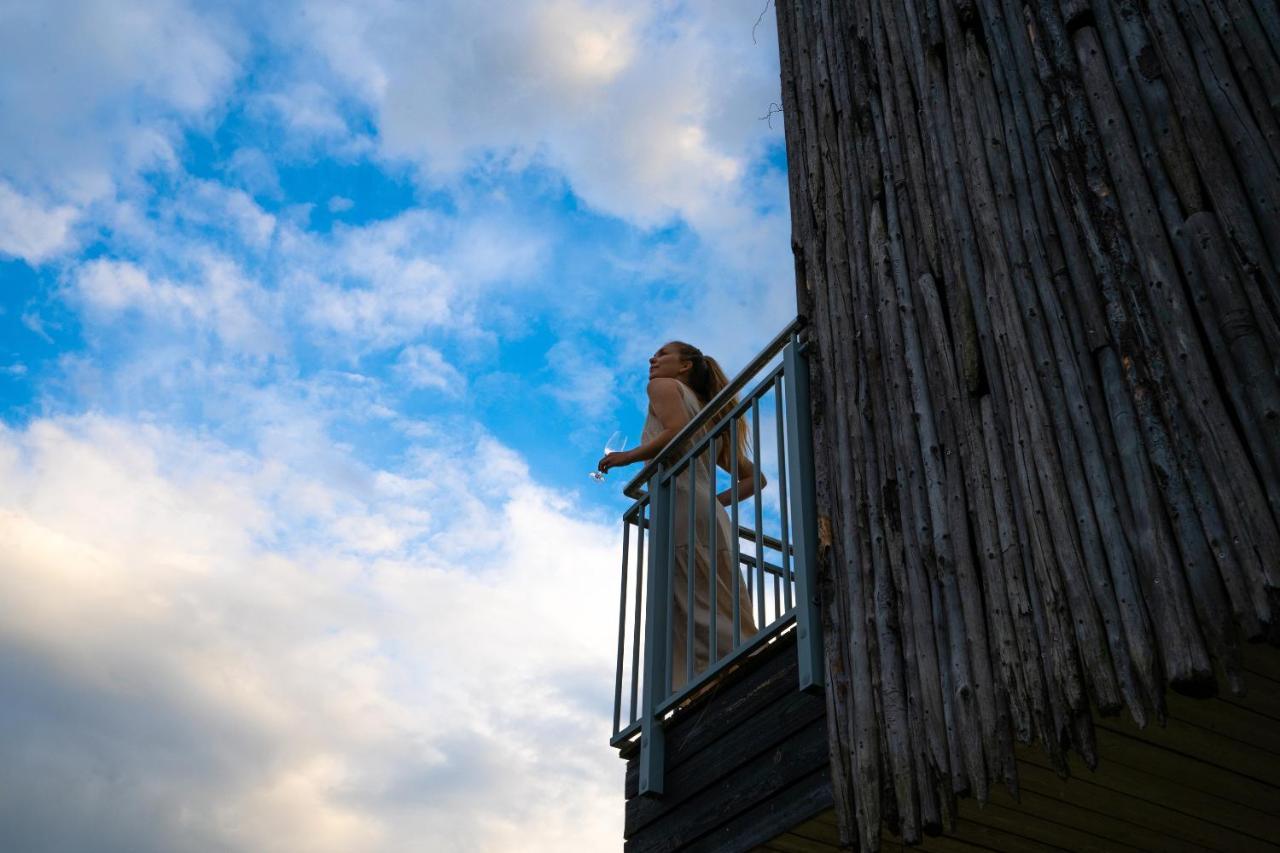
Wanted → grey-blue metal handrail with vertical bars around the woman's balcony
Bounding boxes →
[612,318,822,795]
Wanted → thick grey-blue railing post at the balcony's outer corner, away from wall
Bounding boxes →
[640,465,671,797]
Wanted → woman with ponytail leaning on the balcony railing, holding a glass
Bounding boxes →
[599,341,764,690]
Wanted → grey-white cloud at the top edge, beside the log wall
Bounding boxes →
[300,0,781,227]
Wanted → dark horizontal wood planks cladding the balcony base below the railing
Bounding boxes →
[623,634,831,853]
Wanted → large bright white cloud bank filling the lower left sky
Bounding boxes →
[0,418,622,853]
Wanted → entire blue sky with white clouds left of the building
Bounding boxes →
[0,0,794,853]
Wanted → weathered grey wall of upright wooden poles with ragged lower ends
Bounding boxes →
[777,0,1280,849]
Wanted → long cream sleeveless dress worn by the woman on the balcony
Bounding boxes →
[640,382,755,690]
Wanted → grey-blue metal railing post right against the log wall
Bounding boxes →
[782,334,823,690]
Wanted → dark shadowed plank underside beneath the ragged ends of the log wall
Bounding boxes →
[752,647,1280,853]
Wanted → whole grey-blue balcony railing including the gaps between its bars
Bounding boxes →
[612,318,822,795]
